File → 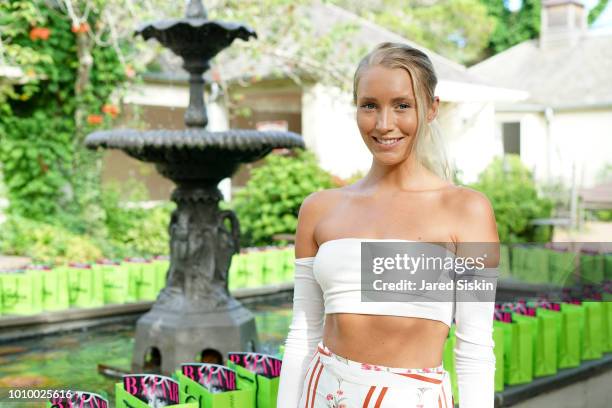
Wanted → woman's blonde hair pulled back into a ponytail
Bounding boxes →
[353,42,452,180]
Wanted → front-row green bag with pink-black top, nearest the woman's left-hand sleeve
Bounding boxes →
[227,352,281,408]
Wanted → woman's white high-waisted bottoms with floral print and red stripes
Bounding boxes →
[298,342,454,408]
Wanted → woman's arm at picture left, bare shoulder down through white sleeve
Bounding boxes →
[277,193,325,408]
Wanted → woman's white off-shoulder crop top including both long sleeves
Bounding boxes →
[277,238,495,408]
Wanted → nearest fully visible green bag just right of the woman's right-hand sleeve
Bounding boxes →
[493,313,535,385]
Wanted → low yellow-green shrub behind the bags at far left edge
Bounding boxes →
[0,216,102,264]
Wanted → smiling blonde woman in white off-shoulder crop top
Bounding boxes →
[277,43,498,408]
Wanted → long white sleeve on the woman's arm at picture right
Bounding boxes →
[455,268,497,408]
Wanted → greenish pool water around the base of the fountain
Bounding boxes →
[0,302,291,407]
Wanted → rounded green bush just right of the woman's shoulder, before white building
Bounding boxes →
[471,155,552,243]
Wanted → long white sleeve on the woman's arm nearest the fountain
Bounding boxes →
[277,257,325,408]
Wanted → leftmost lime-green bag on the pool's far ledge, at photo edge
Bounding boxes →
[0,270,35,315]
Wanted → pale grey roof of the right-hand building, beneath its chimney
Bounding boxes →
[469,30,612,109]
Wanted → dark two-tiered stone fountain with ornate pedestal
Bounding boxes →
[85,0,304,375]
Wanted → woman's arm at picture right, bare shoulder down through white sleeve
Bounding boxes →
[455,189,499,408]
